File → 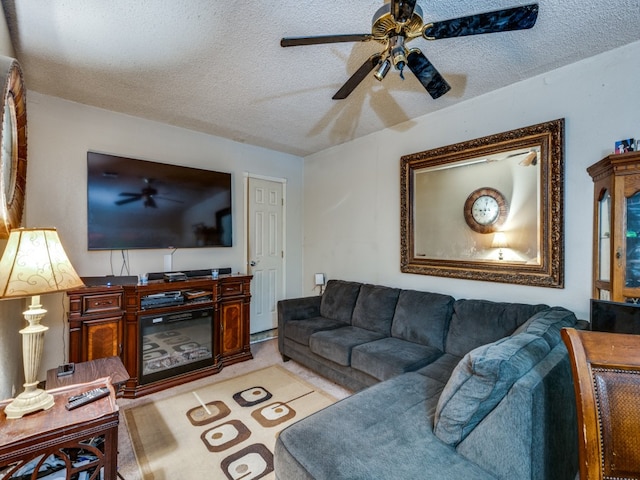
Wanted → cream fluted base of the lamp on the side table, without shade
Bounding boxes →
[4,295,54,418]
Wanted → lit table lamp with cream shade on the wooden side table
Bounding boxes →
[0,228,84,418]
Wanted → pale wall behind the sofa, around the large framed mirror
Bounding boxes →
[304,42,640,319]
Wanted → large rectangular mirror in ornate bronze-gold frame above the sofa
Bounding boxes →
[400,119,564,288]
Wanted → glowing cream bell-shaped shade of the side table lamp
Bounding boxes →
[0,228,84,298]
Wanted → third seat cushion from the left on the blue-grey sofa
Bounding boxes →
[351,337,444,383]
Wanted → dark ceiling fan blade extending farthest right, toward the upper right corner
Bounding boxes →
[422,3,538,40]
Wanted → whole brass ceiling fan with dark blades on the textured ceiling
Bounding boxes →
[280,0,538,100]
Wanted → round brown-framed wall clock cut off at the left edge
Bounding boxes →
[0,56,27,238]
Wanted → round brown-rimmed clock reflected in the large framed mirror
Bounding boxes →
[464,187,509,233]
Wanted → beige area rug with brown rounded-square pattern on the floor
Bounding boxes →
[123,365,335,480]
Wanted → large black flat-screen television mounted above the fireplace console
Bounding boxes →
[87,152,233,250]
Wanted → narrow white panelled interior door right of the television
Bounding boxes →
[247,177,284,333]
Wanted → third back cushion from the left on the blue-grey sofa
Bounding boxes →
[391,290,454,351]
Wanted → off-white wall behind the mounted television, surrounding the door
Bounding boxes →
[20,93,303,378]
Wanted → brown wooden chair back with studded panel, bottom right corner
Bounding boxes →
[562,328,640,480]
